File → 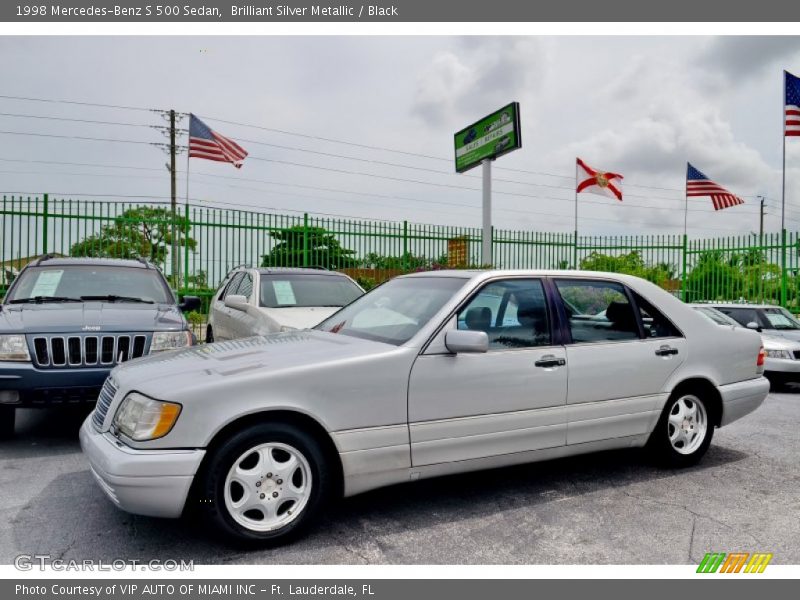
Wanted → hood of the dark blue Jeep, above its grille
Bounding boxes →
[0,302,185,334]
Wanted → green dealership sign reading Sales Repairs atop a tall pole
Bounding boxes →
[453,102,522,173]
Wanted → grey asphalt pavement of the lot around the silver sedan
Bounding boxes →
[0,388,800,564]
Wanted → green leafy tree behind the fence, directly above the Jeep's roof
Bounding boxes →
[69,206,197,266]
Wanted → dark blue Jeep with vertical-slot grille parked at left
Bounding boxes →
[0,256,200,437]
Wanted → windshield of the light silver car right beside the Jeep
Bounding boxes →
[259,273,364,308]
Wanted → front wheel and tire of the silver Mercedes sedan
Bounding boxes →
[199,423,333,545]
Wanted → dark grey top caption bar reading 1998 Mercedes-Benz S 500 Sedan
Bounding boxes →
[0,0,800,23]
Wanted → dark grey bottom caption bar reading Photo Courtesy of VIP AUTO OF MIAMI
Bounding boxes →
[0,580,797,600]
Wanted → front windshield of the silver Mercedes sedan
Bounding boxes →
[314,277,469,346]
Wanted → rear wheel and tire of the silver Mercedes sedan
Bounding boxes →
[648,391,714,468]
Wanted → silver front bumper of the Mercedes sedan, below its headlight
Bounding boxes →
[80,415,205,518]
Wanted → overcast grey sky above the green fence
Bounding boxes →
[0,36,800,236]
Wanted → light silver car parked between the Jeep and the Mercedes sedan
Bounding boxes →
[206,268,364,342]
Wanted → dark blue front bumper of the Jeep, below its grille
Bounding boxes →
[0,362,111,406]
